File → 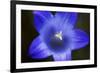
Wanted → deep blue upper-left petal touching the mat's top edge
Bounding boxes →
[33,11,53,32]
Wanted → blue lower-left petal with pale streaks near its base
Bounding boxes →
[29,37,51,59]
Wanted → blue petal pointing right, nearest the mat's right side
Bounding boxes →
[70,29,89,50]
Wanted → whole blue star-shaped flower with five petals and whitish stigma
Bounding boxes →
[29,11,89,61]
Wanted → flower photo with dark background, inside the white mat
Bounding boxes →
[21,10,90,62]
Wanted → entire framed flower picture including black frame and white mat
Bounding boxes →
[11,1,97,72]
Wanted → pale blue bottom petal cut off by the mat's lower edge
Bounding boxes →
[53,49,71,61]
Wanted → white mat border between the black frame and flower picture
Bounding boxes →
[16,4,95,69]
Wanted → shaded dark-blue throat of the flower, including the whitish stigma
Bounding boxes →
[43,28,69,52]
